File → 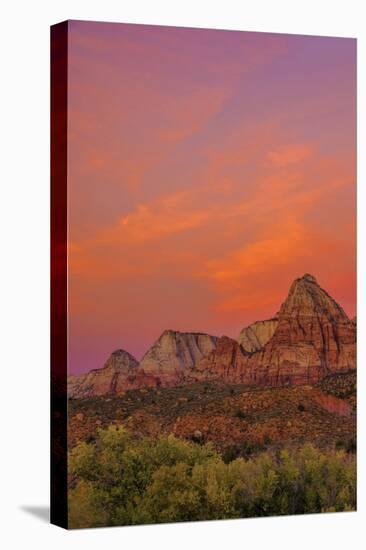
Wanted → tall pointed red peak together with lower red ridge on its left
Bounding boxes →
[195,274,356,386]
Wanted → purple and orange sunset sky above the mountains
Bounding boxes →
[68,21,356,373]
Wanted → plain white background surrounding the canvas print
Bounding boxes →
[0,0,366,550]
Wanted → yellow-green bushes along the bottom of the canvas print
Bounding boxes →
[69,426,356,528]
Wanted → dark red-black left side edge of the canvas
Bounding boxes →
[50,21,68,529]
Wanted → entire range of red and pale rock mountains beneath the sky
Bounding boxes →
[68,273,356,397]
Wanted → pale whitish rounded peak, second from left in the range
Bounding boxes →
[140,330,218,386]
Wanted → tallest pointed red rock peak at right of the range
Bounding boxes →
[250,274,356,385]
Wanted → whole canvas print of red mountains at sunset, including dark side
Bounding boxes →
[51,21,356,528]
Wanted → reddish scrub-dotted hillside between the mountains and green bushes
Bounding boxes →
[69,374,356,459]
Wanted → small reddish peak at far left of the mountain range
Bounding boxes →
[68,349,154,398]
